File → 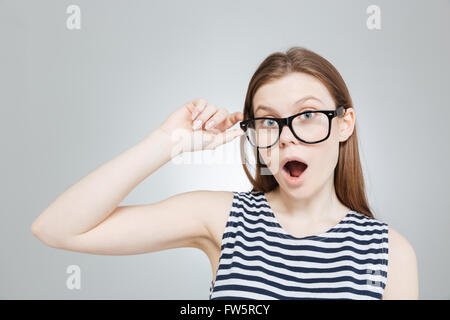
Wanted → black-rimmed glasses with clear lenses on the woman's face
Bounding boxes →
[239,106,345,148]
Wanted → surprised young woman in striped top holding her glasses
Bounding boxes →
[31,47,418,299]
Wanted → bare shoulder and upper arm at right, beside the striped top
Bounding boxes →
[383,227,419,299]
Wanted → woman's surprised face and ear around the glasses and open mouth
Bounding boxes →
[253,72,355,198]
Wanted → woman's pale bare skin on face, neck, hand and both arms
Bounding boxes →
[31,73,418,299]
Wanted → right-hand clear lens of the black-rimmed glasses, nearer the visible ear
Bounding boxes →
[292,112,329,142]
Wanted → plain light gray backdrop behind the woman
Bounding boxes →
[0,0,450,299]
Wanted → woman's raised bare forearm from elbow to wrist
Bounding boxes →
[32,129,176,241]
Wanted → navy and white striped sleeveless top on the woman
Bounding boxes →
[209,191,388,300]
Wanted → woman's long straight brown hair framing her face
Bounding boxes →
[240,47,374,218]
